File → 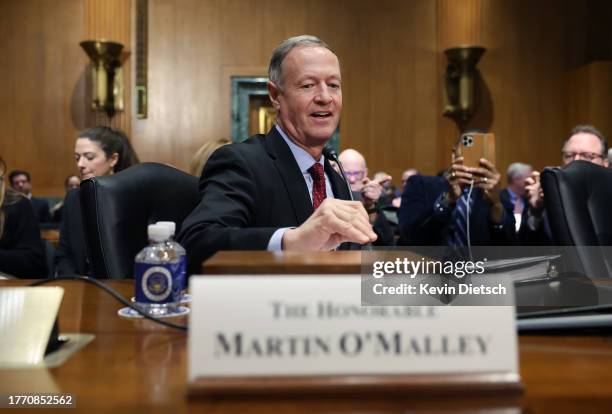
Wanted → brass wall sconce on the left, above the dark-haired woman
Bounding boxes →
[80,40,124,118]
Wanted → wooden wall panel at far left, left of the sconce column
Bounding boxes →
[0,0,86,196]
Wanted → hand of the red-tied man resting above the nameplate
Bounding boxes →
[282,198,377,250]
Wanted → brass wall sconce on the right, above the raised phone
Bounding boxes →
[443,46,486,122]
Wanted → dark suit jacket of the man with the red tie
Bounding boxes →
[178,128,350,273]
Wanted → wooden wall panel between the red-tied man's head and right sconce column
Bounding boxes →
[341,1,436,181]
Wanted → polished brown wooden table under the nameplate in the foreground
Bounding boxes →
[0,274,612,414]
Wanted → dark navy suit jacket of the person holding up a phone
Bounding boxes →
[398,175,516,246]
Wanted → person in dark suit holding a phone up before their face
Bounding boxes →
[398,150,516,247]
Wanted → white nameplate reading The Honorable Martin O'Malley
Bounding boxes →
[188,275,518,394]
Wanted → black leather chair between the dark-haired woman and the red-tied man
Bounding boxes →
[80,163,200,279]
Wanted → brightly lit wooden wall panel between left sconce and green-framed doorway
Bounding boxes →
[133,0,229,171]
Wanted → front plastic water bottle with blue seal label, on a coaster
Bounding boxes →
[134,224,181,316]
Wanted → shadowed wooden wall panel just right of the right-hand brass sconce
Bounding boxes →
[481,0,571,171]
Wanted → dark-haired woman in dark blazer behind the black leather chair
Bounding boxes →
[55,126,139,276]
